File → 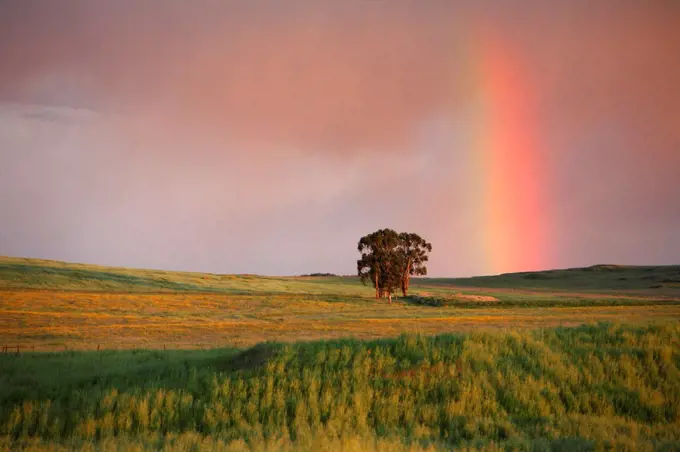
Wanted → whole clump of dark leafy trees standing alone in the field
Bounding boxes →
[357,229,432,303]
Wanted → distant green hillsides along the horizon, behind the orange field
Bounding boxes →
[0,257,680,297]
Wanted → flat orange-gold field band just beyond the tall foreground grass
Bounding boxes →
[0,291,680,350]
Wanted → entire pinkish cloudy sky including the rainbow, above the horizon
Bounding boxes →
[0,0,680,276]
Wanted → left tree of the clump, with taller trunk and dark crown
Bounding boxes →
[357,229,403,302]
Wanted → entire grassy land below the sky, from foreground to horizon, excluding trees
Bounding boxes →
[0,258,680,450]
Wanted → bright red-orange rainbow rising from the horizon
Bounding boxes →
[462,33,551,273]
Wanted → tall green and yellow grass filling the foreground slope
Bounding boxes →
[0,323,680,450]
